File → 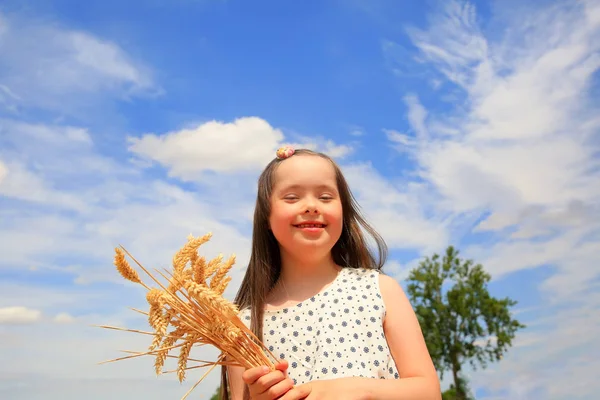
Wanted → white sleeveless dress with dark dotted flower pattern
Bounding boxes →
[240,268,399,385]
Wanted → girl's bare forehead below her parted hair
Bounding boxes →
[274,155,337,187]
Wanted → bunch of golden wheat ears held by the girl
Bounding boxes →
[100,233,276,399]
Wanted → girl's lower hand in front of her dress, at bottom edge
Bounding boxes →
[279,378,365,400]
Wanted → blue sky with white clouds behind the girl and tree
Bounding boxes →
[0,0,600,400]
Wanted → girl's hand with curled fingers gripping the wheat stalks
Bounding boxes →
[242,361,294,400]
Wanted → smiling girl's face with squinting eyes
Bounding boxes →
[269,155,343,258]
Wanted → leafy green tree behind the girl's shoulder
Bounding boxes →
[407,246,525,400]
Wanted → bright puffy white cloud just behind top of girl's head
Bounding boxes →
[129,117,352,181]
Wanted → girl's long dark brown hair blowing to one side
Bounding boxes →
[221,149,387,400]
